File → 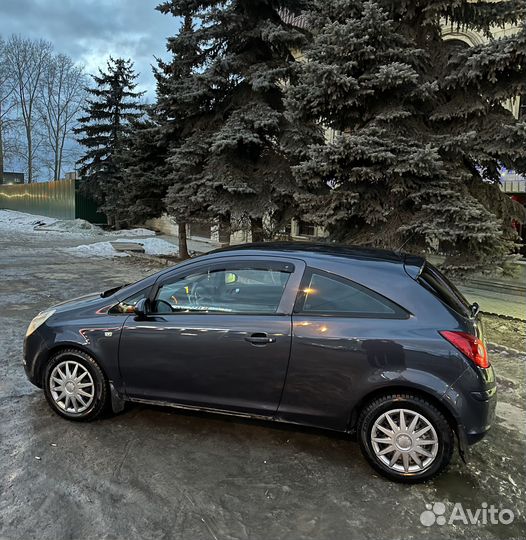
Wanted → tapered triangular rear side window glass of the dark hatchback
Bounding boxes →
[298,271,408,319]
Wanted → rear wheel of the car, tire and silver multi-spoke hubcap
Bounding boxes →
[358,394,455,483]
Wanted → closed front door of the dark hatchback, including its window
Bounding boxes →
[119,257,305,416]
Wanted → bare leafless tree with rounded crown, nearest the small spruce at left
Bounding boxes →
[37,54,87,180]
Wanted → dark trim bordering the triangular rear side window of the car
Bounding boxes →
[293,266,411,321]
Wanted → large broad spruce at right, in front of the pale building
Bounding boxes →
[287,0,526,269]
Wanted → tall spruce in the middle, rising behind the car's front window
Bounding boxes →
[158,0,318,240]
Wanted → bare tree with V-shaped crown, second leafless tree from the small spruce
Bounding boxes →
[5,36,53,183]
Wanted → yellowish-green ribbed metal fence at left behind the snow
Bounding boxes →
[0,180,106,224]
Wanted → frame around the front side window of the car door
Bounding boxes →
[148,256,306,317]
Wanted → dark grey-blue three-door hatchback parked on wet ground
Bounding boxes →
[24,243,496,482]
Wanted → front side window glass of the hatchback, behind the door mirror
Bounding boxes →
[151,263,292,314]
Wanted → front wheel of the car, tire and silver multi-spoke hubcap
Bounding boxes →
[43,349,110,422]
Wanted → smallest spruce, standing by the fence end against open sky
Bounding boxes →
[75,58,143,225]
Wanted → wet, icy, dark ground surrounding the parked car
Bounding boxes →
[0,225,526,540]
